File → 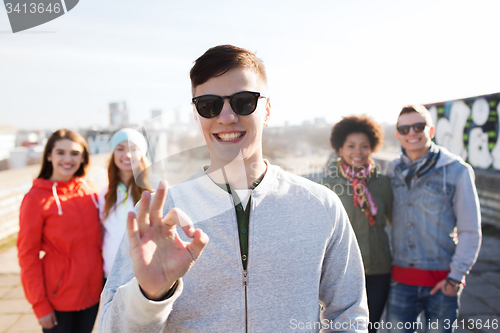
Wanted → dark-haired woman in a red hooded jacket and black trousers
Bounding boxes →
[17,129,103,333]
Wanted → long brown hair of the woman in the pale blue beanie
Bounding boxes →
[102,152,152,221]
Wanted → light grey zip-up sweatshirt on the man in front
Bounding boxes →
[98,165,368,333]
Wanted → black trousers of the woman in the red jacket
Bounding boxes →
[42,303,99,333]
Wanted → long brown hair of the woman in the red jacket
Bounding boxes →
[37,128,89,179]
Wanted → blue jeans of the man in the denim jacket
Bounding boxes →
[387,281,460,333]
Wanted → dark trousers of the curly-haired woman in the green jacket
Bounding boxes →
[365,274,391,333]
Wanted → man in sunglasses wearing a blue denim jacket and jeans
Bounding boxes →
[387,105,481,333]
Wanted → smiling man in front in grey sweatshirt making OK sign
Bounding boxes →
[99,45,368,332]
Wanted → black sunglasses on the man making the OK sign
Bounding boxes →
[193,91,265,118]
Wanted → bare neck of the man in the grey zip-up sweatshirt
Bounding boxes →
[206,154,267,190]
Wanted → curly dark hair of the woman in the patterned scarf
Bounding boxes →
[330,114,384,153]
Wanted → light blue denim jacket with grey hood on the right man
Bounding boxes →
[388,147,481,281]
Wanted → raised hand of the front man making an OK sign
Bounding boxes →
[127,181,208,300]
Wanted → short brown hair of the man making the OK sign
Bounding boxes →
[189,45,267,90]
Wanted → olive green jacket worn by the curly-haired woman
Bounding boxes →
[318,161,393,275]
